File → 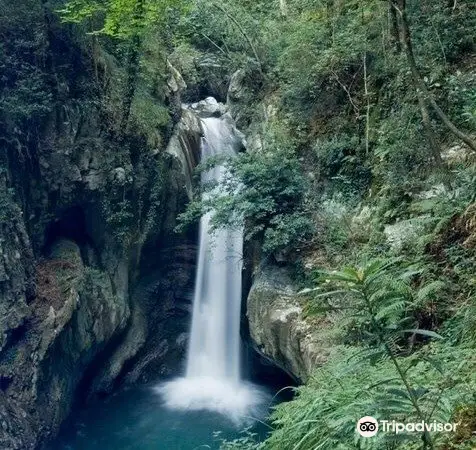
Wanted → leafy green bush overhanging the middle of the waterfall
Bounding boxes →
[180,127,313,252]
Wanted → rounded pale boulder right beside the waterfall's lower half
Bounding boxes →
[247,266,327,382]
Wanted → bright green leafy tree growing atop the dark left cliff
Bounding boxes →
[57,0,187,133]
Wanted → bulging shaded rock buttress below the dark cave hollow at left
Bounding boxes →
[0,238,129,449]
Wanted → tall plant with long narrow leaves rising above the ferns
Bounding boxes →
[310,259,452,449]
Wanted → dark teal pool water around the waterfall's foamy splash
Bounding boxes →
[48,387,267,450]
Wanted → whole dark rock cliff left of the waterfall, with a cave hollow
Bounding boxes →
[0,12,195,450]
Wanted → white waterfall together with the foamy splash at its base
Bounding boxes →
[158,113,264,420]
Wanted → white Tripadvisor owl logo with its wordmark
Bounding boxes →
[357,416,458,437]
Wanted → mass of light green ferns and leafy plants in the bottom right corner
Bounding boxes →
[249,260,476,450]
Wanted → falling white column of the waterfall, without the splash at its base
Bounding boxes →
[187,117,243,382]
